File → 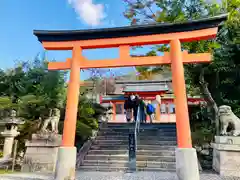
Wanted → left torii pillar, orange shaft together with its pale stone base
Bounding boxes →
[55,46,82,180]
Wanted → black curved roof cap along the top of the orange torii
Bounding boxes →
[33,14,227,42]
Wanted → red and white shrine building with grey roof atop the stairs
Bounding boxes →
[100,80,205,123]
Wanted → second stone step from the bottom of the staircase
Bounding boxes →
[83,160,176,169]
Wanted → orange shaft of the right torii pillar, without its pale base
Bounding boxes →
[170,39,192,148]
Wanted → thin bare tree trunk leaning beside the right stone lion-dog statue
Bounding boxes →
[199,68,220,135]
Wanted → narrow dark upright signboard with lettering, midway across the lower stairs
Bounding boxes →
[128,132,136,171]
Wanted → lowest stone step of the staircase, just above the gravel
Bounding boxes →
[78,165,176,172]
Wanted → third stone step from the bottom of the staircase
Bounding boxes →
[85,154,175,162]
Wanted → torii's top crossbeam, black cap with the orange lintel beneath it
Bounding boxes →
[34,14,227,50]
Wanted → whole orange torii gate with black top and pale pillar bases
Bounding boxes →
[34,15,227,180]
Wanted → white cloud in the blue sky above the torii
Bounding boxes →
[68,0,106,26]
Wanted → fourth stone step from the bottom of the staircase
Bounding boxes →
[88,149,175,156]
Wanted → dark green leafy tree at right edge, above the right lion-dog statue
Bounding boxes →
[210,1,240,115]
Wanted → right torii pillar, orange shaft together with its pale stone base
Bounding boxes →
[170,39,200,180]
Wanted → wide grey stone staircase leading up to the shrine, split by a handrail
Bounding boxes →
[79,123,176,171]
